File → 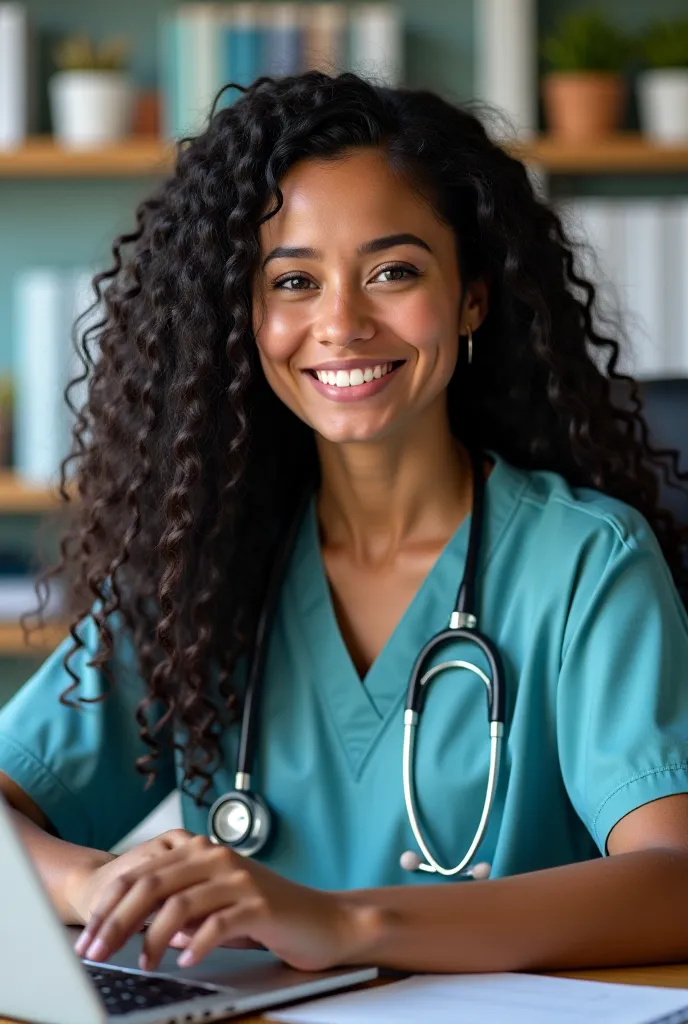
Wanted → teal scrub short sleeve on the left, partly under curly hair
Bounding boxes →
[0,616,175,850]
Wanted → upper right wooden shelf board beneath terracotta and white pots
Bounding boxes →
[511,132,688,174]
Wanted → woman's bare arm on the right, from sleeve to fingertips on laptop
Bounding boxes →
[71,795,688,972]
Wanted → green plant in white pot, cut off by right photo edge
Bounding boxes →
[638,17,688,142]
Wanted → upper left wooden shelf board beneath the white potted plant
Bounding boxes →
[0,135,174,178]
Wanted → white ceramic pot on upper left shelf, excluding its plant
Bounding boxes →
[49,71,133,148]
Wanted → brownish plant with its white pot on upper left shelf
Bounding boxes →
[48,36,133,147]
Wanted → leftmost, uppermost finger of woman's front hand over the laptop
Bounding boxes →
[80,859,207,961]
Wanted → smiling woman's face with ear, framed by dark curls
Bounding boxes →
[253,150,484,443]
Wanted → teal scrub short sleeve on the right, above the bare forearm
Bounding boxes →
[557,515,688,854]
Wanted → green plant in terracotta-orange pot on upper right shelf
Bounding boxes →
[542,9,630,141]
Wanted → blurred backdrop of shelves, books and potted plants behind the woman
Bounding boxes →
[0,0,688,703]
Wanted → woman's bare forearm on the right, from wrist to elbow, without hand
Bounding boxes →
[341,850,688,972]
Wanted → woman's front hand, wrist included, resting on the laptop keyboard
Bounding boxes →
[75,836,377,971]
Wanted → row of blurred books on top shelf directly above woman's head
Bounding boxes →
[160,2,404,138]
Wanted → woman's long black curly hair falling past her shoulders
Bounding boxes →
[25,72,688,800]
